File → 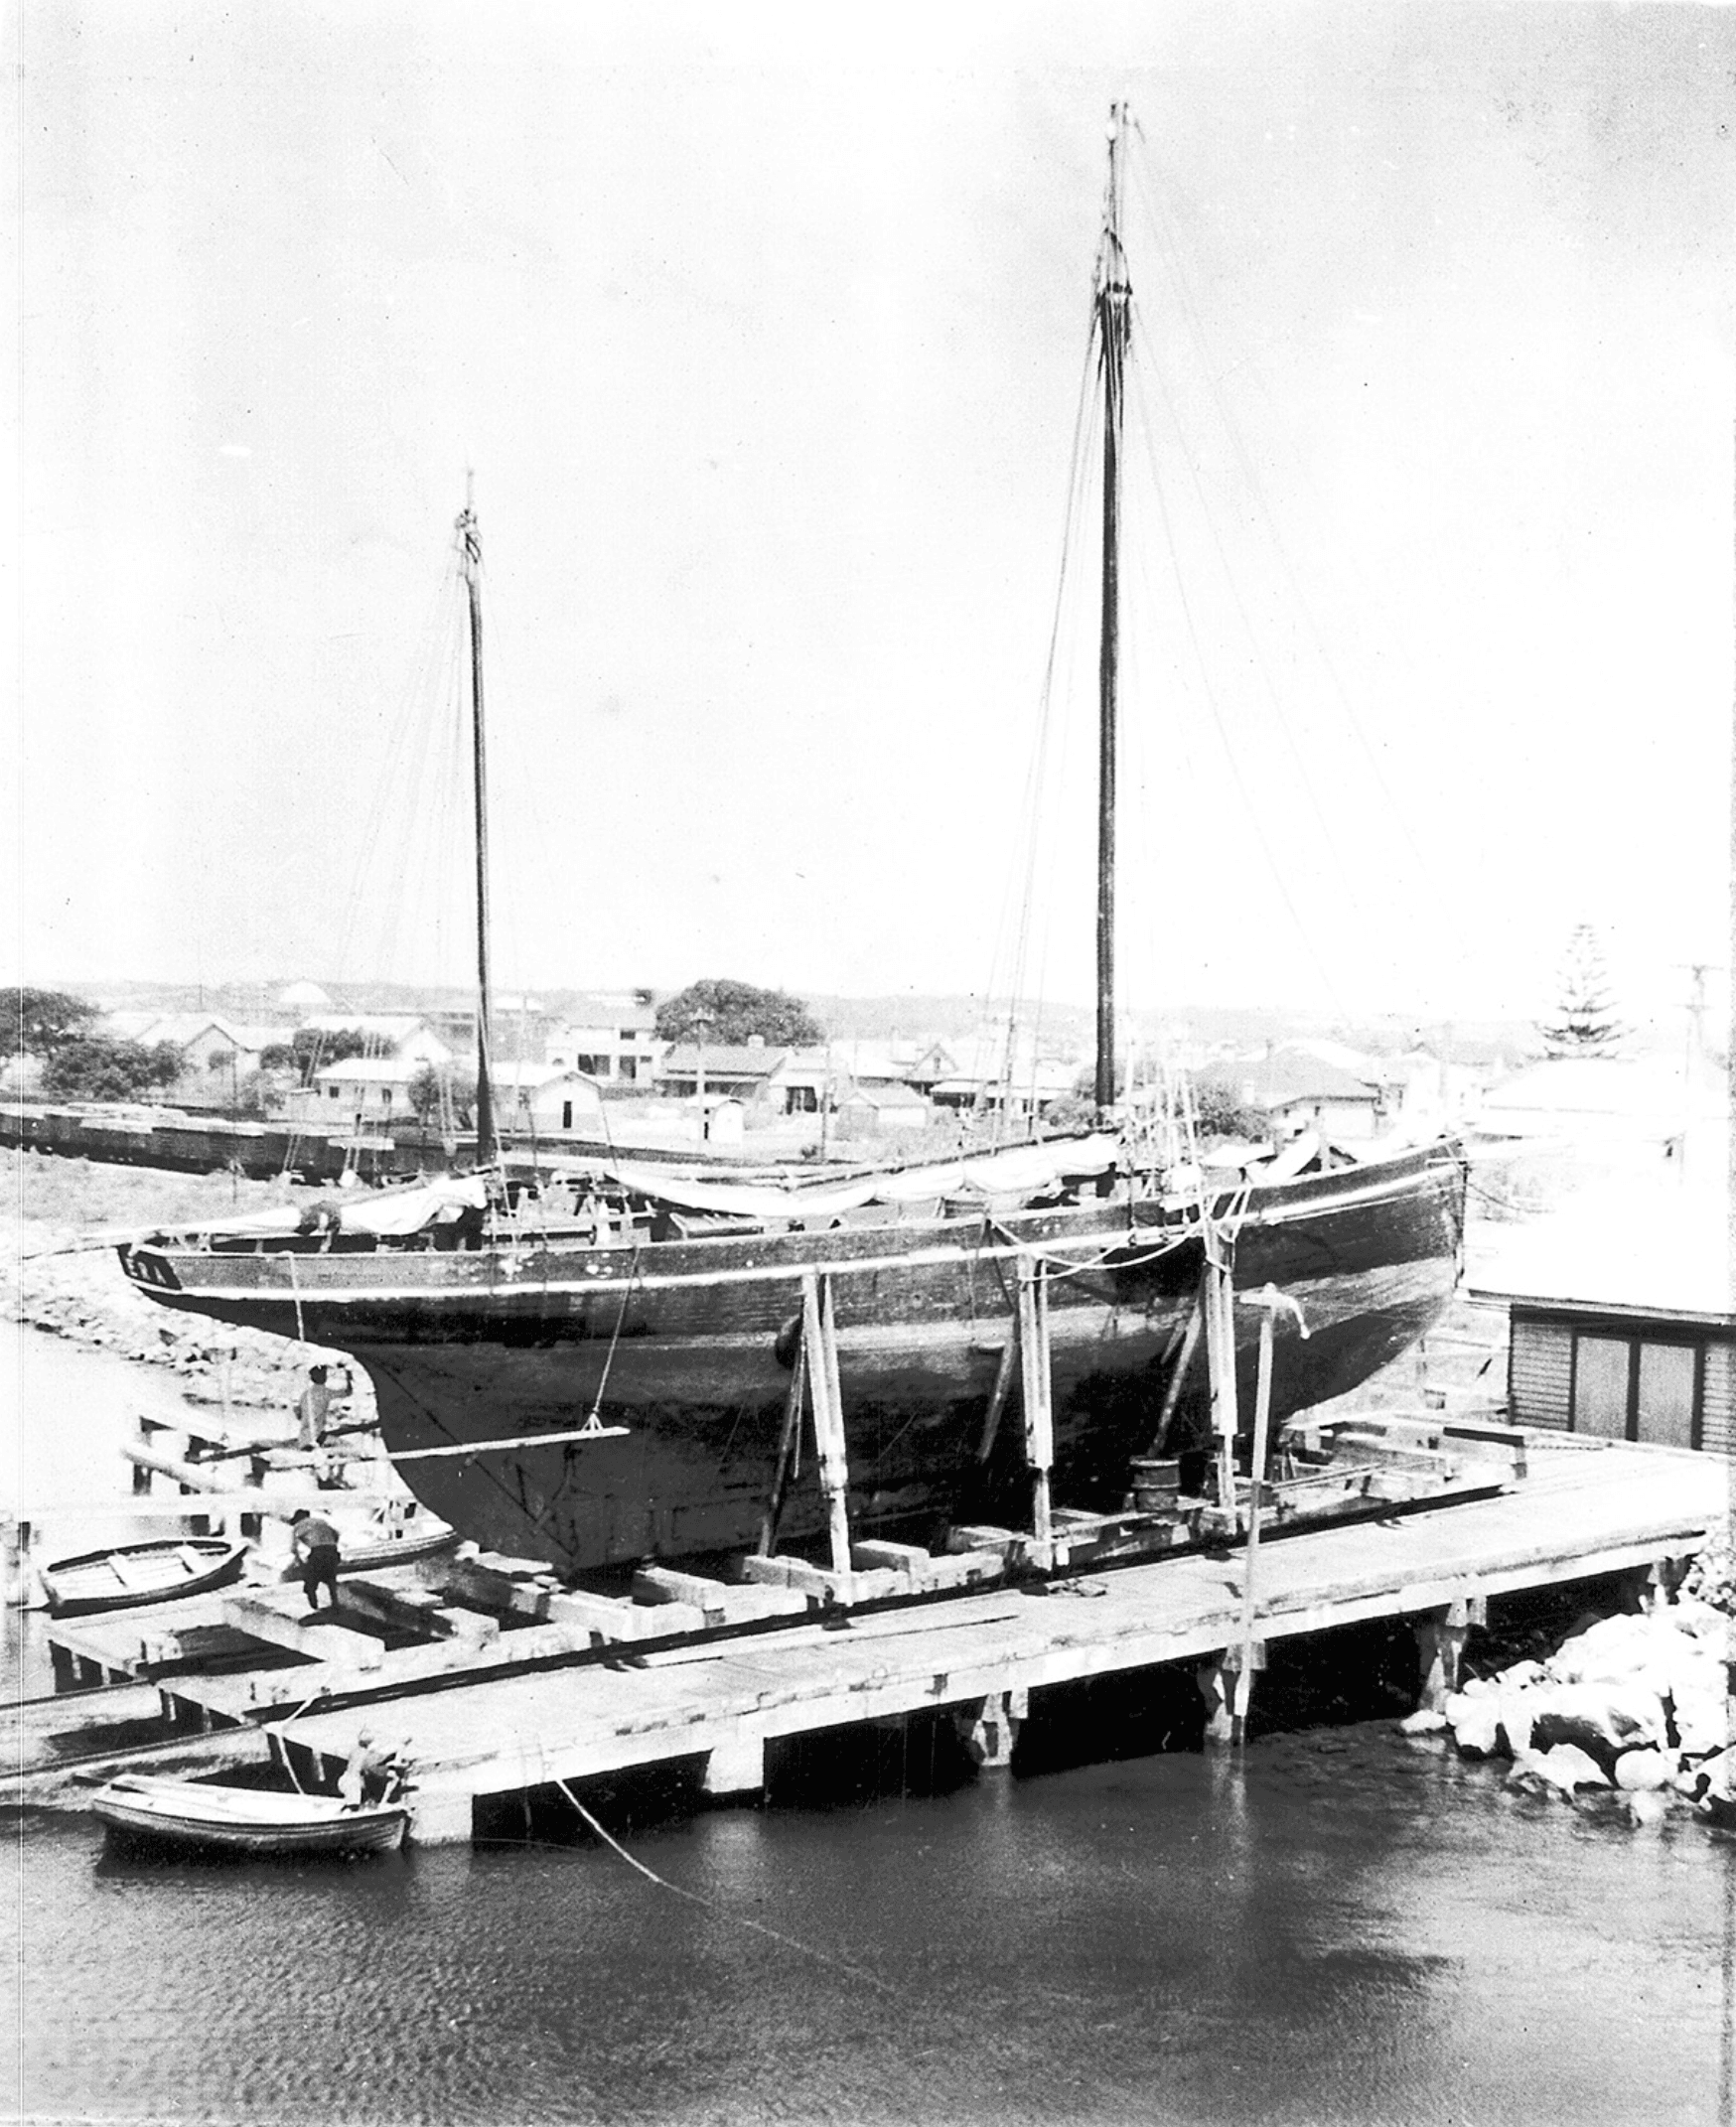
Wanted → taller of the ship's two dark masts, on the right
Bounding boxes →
[1095,104,1132,1112]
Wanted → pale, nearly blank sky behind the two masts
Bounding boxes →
[4,0,1736,1046]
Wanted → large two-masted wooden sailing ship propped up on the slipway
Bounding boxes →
[121,106,1464,1574]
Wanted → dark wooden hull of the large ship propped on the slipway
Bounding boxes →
[123,1147,1464,1572]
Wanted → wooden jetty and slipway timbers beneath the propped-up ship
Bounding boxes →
[19,1429,1730,1844]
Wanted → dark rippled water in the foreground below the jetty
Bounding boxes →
[4,1319,1736,2127]
